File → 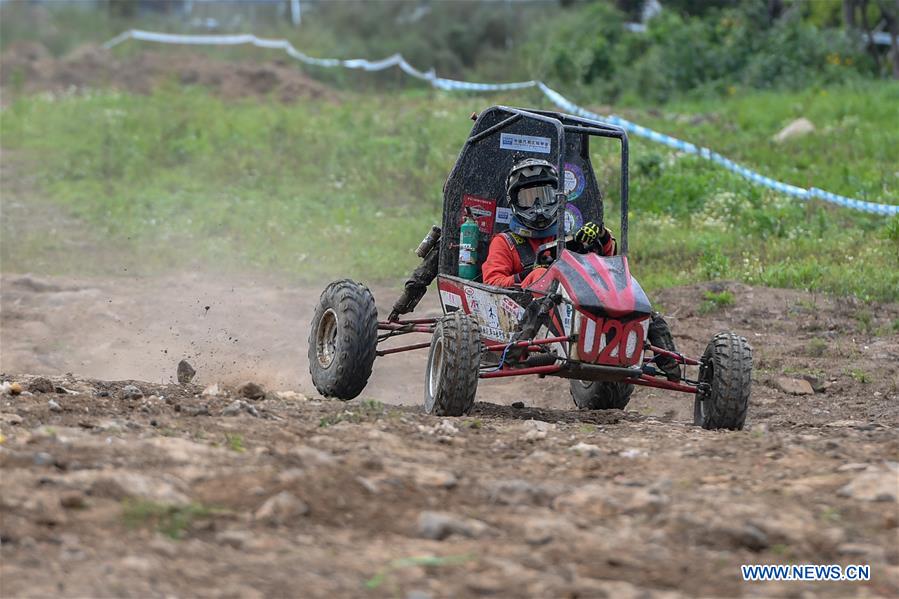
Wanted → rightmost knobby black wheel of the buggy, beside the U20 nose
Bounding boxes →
[693,333,752,430]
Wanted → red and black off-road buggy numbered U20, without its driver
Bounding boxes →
[309,106,752,429]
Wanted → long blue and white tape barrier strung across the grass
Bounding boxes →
[104,29,899,216]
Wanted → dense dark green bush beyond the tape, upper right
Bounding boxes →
[526,0,873,102]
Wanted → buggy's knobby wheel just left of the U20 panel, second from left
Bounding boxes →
[425,311,481,416]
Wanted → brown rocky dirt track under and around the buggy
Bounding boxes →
[0,275,899,597]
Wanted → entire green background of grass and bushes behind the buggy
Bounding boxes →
[0,0,899,301]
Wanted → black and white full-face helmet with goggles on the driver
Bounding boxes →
[506,158,559,235]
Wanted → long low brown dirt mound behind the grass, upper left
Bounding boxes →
[0,42,337,103]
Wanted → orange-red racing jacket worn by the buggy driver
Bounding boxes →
[481,229,616,288]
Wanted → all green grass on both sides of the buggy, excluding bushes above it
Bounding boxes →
[0,83,899,301]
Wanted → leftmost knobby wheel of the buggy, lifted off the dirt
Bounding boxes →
[309,279,378,400]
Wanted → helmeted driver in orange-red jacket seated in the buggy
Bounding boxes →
[481,158,617,287]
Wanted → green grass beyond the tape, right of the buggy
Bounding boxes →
[625,81,899,209]
